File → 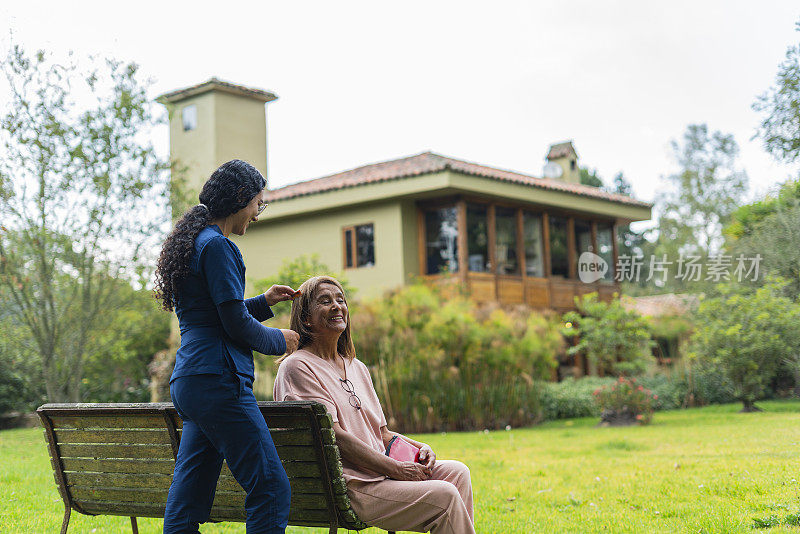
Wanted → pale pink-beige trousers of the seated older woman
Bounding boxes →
[347,460,475,534]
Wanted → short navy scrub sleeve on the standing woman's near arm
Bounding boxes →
[200,236,244,305]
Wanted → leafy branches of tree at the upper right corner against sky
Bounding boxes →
[753,22,800,163]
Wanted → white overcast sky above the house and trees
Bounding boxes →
[0,0,800,209]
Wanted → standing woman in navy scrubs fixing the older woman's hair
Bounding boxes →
[155,160,298,534]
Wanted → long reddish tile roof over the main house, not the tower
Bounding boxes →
[267,152,652,207]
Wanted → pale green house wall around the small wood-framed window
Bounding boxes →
[231,201,406,297]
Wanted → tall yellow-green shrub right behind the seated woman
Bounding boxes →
[351,284,563,432]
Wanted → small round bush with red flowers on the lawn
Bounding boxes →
[594,376,658,426]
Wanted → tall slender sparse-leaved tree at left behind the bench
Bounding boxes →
[0,46,169,402]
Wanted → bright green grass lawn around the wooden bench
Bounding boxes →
[0,401,800,534]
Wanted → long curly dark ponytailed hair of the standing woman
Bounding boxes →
[154,159,267,311]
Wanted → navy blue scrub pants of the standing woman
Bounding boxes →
[164,372,291,534]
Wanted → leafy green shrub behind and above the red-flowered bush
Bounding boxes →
[563,293,653,375]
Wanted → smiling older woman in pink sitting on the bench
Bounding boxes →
[274,276,475,534]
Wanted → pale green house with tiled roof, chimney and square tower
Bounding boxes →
[160,79,652,311]
